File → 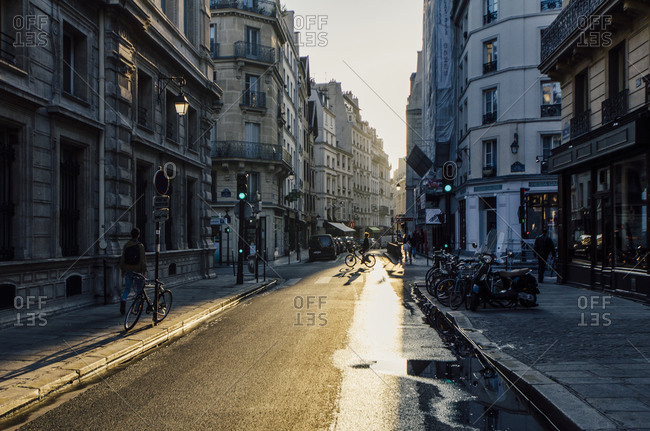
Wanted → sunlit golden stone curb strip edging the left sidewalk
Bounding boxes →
[0,279,278,419]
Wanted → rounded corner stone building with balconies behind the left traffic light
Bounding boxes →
[210,0,313,262]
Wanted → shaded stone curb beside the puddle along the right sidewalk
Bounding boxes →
[412,286,619,431]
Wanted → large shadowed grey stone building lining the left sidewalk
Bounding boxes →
[0,0,221,323]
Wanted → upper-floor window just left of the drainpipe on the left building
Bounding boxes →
[62,25,88,99]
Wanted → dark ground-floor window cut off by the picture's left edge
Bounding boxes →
[0,128,18,261]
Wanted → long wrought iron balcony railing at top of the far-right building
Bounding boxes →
[541,0,610,63]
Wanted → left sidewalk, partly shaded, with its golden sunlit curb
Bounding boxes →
[0,269,278,417]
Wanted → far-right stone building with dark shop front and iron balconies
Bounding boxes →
[539,0,650,299]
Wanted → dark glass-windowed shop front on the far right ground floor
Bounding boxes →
[551,115,650,298]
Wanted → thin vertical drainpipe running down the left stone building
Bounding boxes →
[99,9,107,254]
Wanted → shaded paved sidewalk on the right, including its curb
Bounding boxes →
[404,261,650,431]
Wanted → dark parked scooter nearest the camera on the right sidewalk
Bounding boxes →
[467,254,540,311]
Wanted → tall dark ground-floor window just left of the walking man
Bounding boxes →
[59,146,81,256]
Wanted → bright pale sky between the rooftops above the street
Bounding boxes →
[282,0,423,177]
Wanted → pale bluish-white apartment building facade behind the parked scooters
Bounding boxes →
[448,0,562,253]
